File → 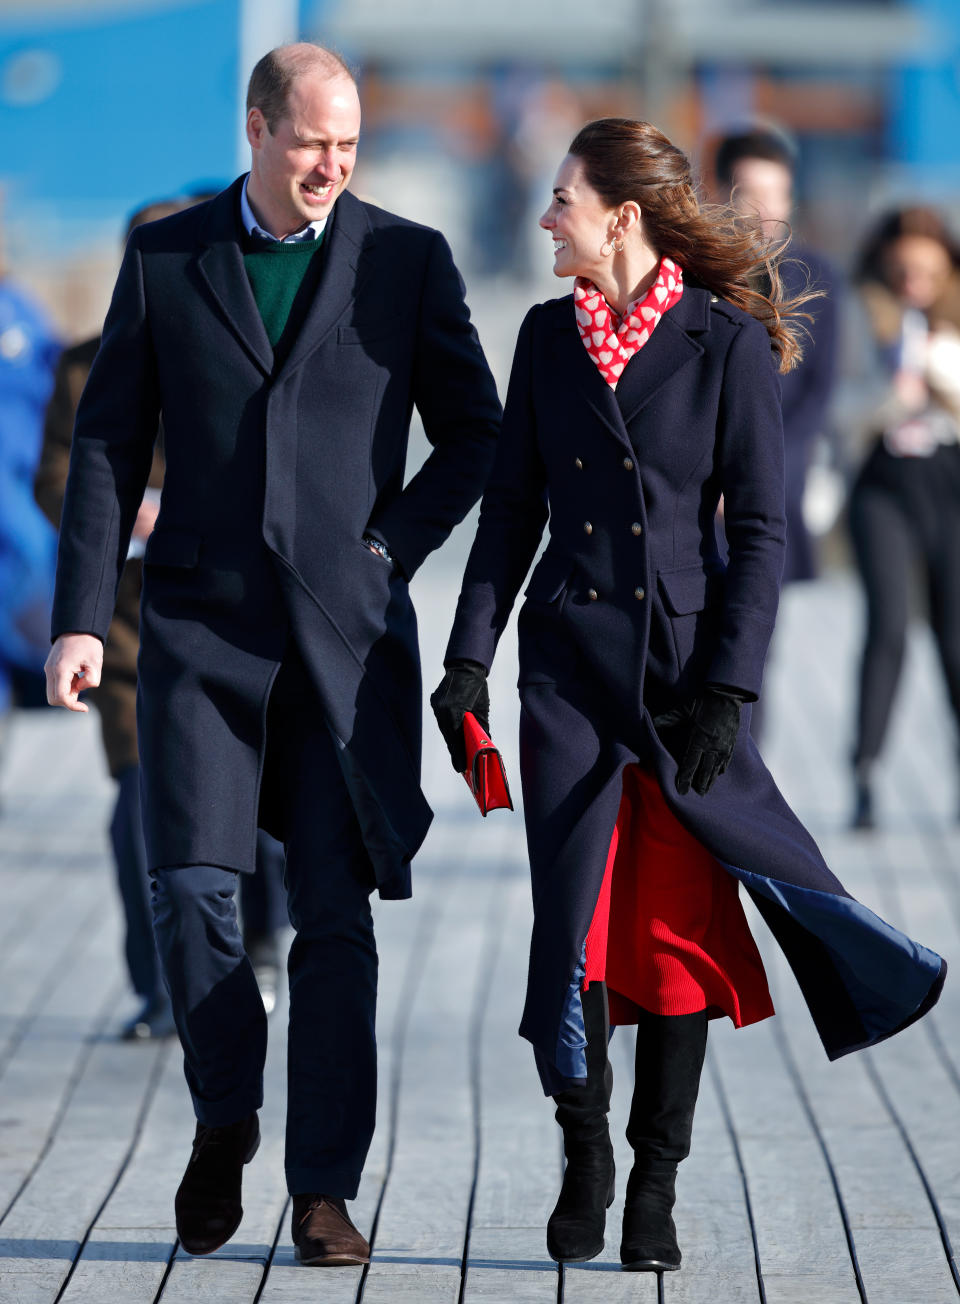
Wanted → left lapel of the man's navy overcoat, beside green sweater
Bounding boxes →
[197,179,274,376]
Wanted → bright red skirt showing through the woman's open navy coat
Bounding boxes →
[584,765,773,1028]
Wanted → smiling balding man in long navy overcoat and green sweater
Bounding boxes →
[47,44,500,1264]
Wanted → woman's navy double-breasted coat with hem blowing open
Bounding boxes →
[446,284,946,1091]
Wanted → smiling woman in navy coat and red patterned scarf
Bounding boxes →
[432,119,946,1270]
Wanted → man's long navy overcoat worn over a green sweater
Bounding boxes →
[53,177,501,897]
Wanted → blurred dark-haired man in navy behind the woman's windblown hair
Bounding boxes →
[713,126,837,738]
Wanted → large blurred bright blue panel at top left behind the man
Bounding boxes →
[0,0,322,249]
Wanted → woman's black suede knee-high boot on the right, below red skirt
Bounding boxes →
[620,1011,707,1273]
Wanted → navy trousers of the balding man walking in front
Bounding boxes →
[154,651,377,1200]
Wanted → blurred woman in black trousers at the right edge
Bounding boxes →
[849,207,960,828]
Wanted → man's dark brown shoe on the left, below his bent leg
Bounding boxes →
[173,1114,260,1254]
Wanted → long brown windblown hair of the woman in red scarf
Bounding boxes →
[569,117,822,372]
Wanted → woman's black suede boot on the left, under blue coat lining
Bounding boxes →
[547,982,613,1264]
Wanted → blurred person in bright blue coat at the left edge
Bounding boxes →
[0,230,60,743]
